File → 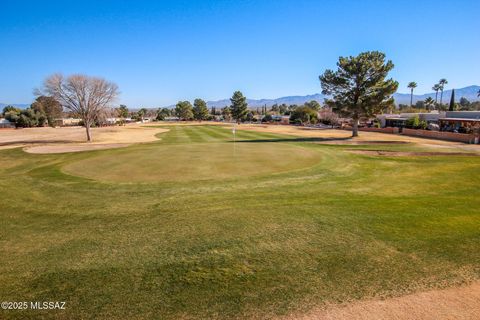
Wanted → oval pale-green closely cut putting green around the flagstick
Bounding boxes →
[63,143,320,182]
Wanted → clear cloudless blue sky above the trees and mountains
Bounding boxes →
[0,0,480,107]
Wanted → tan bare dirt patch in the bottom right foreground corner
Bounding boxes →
[285,282,480,320]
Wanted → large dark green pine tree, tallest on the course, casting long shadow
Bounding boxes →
[319,51,398,137]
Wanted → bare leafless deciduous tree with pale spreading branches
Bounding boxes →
[43,74,119,141]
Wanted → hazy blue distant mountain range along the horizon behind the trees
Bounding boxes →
[0,85,480,110]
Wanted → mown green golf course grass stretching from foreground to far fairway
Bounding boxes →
[0,126,480,319]
